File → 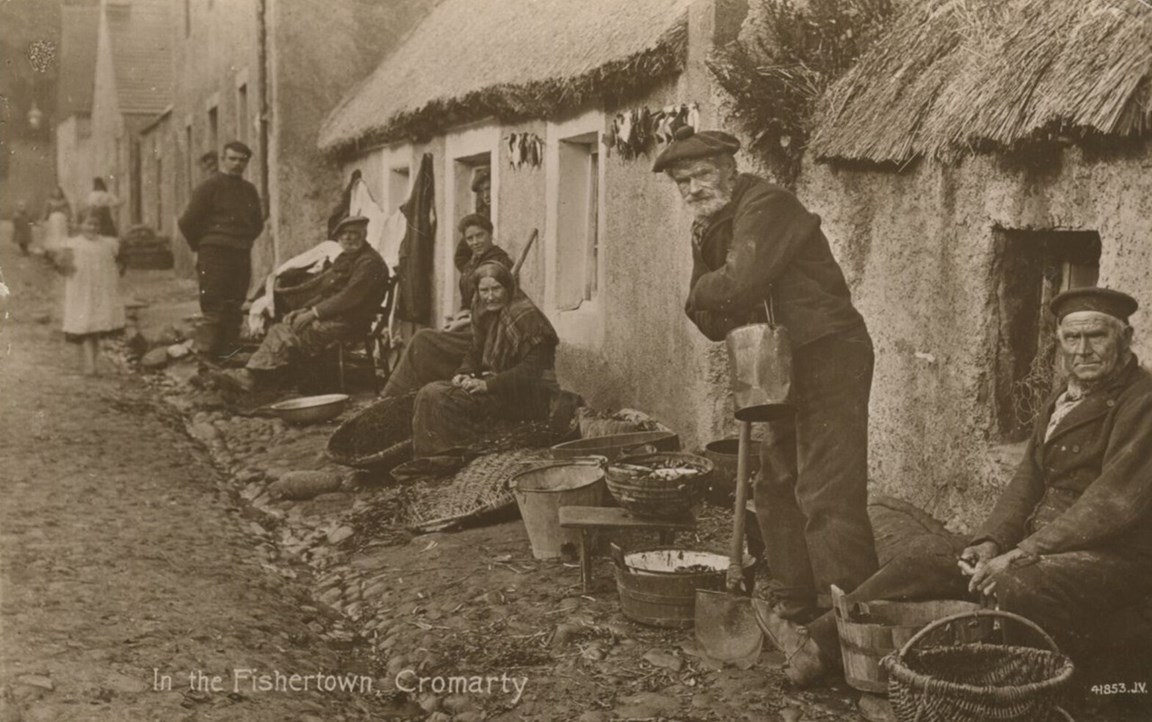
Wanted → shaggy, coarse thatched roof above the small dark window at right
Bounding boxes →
[809,0,1152,164]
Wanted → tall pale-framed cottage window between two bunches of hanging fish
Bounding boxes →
[556,132,601,311]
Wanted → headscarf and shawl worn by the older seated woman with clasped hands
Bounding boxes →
[472,261,560,373]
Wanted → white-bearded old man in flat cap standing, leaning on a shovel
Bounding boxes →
[652,127,877,672]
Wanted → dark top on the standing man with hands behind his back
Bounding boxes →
[179,173,264,251]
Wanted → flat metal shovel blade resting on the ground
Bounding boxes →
[696,590,764,669]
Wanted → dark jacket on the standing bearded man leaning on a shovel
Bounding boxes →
[684,174,864,348]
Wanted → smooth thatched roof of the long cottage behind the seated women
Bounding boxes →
[319,0,689,153]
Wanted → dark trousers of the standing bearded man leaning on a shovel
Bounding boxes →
[753,329,878,618]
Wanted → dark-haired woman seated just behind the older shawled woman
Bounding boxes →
[384,213,511,398]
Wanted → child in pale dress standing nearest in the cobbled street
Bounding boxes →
[53,210,124,375]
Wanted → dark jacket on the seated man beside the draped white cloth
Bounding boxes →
[313,244,388,330]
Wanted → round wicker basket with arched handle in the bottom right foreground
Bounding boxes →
[880,609,1073,722]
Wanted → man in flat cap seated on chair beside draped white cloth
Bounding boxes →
[214,215,388,392]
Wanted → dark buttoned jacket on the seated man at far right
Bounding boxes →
[973,357,1152,557]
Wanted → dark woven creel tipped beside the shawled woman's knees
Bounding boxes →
[325,394,416,473]
